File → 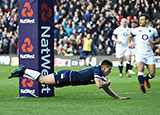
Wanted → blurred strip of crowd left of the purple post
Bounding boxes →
[0,0,18,54]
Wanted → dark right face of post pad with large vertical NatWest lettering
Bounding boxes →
[38,0,54,97]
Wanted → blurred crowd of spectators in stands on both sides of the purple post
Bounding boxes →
[0,0,160,55]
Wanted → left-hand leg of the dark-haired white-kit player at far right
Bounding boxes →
[136,62,146,93]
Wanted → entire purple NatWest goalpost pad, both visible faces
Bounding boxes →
[18,0,54,97]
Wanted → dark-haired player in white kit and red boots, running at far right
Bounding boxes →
[128,14,160,93]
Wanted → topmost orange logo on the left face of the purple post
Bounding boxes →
[21,2,33,17]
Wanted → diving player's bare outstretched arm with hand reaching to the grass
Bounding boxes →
[103,87,131,100]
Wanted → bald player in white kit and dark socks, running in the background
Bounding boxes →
[112,18,134,77]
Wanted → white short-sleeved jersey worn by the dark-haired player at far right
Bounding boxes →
[131,26,158,56]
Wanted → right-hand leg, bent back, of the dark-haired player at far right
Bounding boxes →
[145,64,156,88]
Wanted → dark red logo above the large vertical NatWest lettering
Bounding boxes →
[41,3,52,22]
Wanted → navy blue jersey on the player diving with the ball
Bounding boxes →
[70,65,102,85]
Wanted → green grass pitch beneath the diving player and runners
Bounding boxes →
[0,65,160,115]
